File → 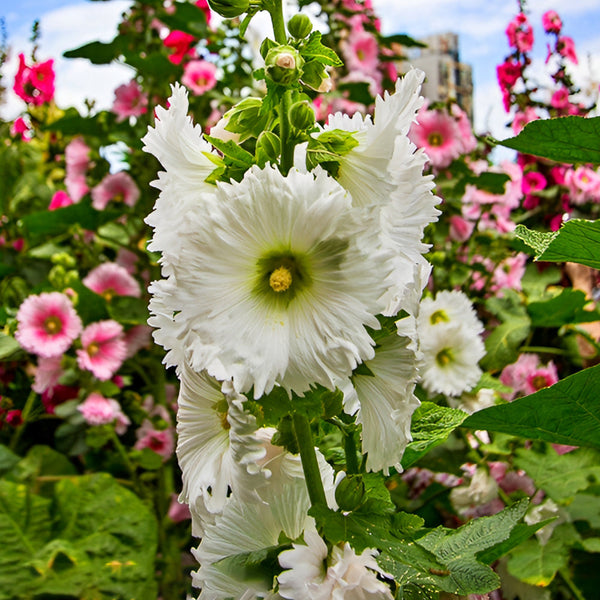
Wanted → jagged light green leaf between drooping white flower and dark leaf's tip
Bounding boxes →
[402,402,468,469]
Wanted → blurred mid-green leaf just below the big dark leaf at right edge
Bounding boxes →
[515,448,600,503]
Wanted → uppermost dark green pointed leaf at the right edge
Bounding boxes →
[498,117,600,163]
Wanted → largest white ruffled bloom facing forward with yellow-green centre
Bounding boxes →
[157,166,388,398]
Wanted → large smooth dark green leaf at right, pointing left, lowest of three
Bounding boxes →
[462,365,600,449]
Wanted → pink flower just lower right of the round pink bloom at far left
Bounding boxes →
[77,320,127,381]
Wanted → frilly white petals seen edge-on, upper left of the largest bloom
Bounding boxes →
[142,84,215,274]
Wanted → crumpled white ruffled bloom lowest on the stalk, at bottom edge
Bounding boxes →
[277,528,393,600]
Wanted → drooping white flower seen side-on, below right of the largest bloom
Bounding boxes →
[340,335,420,475]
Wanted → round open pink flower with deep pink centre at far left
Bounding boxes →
[15,292,82,358]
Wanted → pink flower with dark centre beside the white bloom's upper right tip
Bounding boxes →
[408,106,462,169]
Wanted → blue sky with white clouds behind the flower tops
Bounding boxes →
[0,0,600,136]
